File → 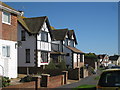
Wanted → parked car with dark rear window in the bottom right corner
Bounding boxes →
[96,69,120,90]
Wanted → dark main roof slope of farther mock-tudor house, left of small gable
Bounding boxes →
[51,28,68,41]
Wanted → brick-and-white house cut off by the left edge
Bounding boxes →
[0,2,21,78]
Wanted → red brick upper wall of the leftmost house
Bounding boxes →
[0,14,17,41]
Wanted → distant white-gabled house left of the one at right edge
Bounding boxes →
[98,54,111,67]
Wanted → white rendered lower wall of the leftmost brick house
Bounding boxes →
[0,40,17,78]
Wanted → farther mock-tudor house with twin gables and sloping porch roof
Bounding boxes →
[51,29,84,68]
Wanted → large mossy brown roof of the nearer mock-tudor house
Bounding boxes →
[18,16,50,34]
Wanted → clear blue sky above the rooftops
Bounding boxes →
[6,2,118,55]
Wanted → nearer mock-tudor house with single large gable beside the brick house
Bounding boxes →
[18,16,51,73]
